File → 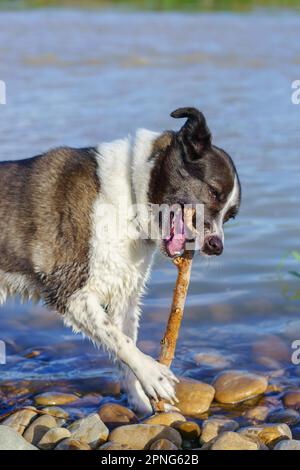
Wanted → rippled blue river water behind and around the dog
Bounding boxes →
[0,10,300,415]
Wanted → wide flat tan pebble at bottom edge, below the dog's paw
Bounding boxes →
[109,424,182,450]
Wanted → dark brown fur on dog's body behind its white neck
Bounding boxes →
[0,148,100,313]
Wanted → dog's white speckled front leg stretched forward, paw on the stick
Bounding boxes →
[64,289,178,403]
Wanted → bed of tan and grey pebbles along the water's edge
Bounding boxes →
[0,370,300,451]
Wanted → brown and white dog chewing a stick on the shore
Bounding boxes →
[0,108,241,414]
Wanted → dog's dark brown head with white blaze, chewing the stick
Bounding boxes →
[149,108,241,257]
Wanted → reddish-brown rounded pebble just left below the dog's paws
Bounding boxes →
[98,403,138,430]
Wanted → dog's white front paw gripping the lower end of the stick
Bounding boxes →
[133,353,179,405]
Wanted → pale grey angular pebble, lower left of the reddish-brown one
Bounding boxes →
[68,413,109,449]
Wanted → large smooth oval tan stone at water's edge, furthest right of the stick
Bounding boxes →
[213,371,268,404]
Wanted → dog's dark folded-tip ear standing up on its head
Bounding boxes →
[171,108,211,160]
